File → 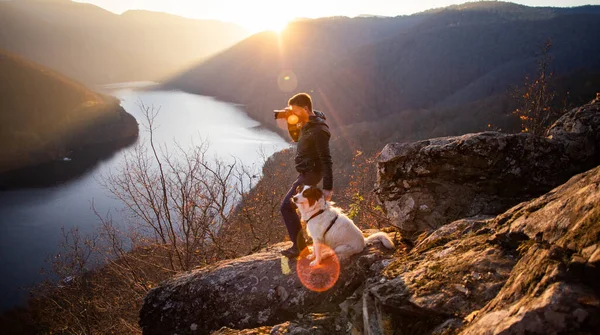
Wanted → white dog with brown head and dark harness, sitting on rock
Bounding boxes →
[292,186,395,266]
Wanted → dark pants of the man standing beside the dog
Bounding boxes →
[281,171,323,248]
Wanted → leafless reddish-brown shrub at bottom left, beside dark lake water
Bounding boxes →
[28,228,150,334]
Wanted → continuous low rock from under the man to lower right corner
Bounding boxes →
[140,167,600,334]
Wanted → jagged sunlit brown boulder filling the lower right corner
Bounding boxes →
[352,167,600,335]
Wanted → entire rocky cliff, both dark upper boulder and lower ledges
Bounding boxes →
[140,101,600,334]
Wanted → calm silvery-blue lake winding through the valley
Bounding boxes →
[0,83,289,310]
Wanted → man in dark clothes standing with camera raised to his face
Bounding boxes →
[281,93,333,258]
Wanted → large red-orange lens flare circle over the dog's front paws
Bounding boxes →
[296,244,340,292]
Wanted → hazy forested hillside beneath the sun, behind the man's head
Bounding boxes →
[165,2,600,138]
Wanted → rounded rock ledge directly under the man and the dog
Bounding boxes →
[140,242,396,334]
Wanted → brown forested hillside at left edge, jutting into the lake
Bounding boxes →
[0,50,138,176]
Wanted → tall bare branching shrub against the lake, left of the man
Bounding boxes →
[98,104,250,272]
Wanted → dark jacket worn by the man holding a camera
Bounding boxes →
[294,111,333,190]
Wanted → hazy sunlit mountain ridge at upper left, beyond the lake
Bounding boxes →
[0,1,248,85]
